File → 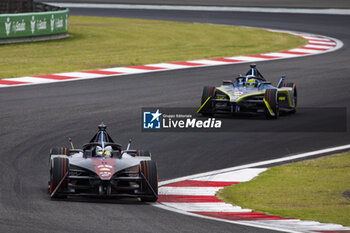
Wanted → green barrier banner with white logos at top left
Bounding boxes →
[0,9,69,40]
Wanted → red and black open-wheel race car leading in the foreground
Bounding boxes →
[49,123,158,202]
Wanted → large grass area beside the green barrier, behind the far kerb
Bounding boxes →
[0,16,306,78]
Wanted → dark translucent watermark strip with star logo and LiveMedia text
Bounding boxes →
[141,107,347,133]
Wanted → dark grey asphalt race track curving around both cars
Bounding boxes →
[0,5,350,232]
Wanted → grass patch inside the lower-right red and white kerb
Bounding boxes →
[217,153,350,226]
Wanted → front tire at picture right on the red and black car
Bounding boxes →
[140,160,158,202]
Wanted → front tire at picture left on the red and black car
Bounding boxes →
[50,157,69,198]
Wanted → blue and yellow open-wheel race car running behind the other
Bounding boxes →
[197,64,297,119]
